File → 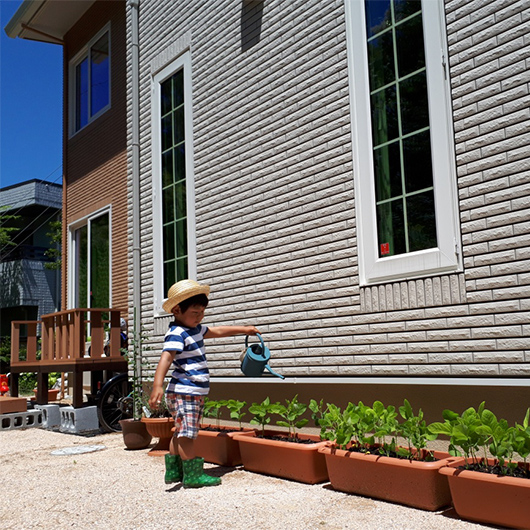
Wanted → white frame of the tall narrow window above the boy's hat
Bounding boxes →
[151,50,197,315]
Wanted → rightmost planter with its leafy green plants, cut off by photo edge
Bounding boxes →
[429,402,530,528]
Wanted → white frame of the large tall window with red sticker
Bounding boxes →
[345,0,462,285]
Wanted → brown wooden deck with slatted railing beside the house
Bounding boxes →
[10,308,127,408]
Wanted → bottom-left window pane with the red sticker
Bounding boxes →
[377,199,407,258]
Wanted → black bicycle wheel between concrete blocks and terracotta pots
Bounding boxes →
[96,373,133,432]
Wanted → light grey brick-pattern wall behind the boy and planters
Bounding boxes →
[129,0,530,377]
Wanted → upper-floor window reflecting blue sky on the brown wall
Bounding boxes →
[70,29,110,134]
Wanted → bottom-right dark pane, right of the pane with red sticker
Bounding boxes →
[407,191,437,252]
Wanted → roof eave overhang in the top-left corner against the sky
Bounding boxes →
[5,0,95,44]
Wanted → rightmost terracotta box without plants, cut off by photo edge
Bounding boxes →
[440,460,530,528]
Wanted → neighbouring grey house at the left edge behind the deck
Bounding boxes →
[0,179,62,337]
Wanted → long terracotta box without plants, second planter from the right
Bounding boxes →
[319,445,462,511]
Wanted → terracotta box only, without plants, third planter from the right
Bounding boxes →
[235,430,329,484]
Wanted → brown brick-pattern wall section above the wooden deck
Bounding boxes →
[62,0,128,310]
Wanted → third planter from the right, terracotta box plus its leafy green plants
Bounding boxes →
[235,395,328,484]
